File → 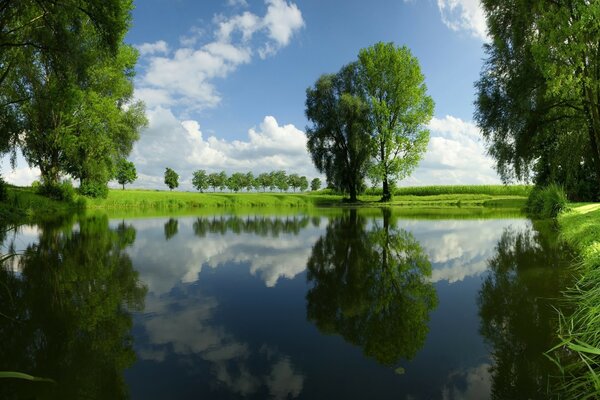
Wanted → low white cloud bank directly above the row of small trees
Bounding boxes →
[130,107,320,190]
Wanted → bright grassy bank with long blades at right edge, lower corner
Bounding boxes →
[552,204,600,399]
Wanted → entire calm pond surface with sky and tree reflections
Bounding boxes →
[0,210,570,399]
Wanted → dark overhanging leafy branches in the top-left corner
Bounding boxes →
[0,0,133,162]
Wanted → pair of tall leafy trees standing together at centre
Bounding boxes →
[306,42,434,201]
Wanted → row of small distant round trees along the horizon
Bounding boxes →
[165,168,321,193]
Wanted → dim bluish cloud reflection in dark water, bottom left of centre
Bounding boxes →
[137,285,304,399]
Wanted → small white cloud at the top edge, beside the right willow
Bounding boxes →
[437,0,488,41]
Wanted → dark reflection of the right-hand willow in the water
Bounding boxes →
[478,222,571,399]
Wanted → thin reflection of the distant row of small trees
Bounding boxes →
[193,215,310,237]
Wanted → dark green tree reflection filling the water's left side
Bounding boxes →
[0,216,146,399]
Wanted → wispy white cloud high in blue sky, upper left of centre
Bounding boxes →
[136,0,304,111]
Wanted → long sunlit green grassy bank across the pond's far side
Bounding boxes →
[0,185,529,221]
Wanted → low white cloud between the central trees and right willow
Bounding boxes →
[400,115,501,186]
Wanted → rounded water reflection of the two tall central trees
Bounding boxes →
[306,210,437,366]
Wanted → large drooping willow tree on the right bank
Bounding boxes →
[475,0,600,198]
